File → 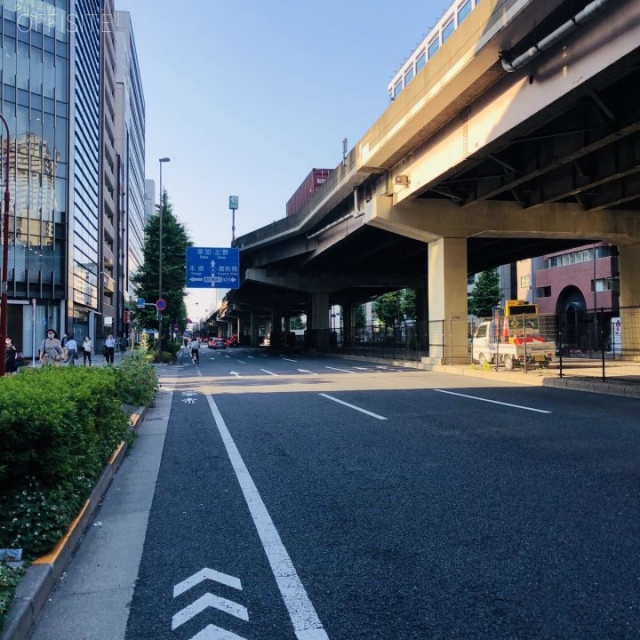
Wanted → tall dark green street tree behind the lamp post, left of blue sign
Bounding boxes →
[131,189,193,339]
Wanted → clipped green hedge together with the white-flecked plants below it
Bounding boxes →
[0,367,131,557]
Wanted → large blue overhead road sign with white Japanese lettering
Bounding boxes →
[187,247,240,289]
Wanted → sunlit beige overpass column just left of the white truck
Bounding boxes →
[428,238,469,364]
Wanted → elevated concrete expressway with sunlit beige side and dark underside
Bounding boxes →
[221,0,640,362]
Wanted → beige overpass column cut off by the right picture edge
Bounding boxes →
[619,244,640,360]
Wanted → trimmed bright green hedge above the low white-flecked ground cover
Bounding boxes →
[0,367,128,490]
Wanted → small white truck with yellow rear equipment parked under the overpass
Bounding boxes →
[471,300,556,369]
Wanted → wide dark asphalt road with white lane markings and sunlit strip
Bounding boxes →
[121,348,640,640]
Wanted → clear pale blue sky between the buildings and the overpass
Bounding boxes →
[116,0,451,320]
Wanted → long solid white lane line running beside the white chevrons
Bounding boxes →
[207,395,329,640]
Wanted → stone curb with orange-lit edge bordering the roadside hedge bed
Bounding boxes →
[0,407,146,640]
